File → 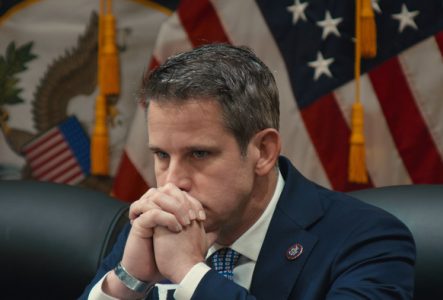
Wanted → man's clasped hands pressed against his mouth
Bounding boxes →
[122,183,216,283]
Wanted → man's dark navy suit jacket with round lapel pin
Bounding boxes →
[80,157,415,300]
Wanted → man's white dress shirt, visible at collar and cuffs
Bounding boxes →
[88,171,284,300]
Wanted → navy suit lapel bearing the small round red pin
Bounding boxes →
[250,159,323,299]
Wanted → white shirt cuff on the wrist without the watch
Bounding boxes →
[173,262,211,300]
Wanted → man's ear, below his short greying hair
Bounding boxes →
[253,128,281,176]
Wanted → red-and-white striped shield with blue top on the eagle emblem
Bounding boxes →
[22,117,90,185]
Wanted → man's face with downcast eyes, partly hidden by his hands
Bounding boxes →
[148,100,256,238]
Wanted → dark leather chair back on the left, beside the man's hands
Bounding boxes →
[0,180,128,299]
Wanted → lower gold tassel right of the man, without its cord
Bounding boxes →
[349,102,368,183]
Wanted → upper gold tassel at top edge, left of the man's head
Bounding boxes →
[99,0,120,96]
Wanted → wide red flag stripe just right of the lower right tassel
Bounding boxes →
[369,58,443,183]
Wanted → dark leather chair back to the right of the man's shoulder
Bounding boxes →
[349,185,443,300]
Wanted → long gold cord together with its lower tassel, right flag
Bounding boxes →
[348,0,368,183]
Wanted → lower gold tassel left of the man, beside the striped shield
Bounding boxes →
[91,95,109,176]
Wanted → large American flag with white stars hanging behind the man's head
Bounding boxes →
[114,0,443,201]
